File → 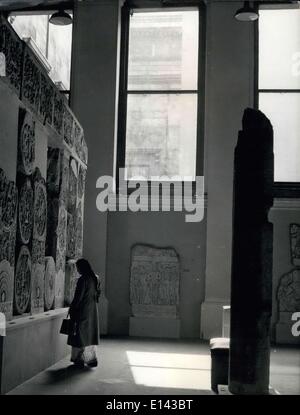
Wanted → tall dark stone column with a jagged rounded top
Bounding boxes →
[229,109,274,394]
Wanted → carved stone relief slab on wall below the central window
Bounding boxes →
[130,245,180,318]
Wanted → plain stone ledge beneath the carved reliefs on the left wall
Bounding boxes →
[0,308,70,394]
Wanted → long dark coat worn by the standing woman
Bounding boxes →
[68,276,99,347]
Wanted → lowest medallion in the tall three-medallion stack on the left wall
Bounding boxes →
[15,246,31,314]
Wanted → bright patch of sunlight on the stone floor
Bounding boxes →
[127,351,211,390]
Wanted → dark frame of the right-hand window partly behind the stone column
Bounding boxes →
[254,1,300,198]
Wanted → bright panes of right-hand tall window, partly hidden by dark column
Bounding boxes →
[259,9,300,185]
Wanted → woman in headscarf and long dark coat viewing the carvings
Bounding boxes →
[68,258,101,367]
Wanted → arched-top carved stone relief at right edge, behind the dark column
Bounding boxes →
[277,269,300,312]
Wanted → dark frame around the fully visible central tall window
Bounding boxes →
[115,1,206,194]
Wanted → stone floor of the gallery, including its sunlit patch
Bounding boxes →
[9,338,300,395]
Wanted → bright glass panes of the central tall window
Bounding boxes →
[119,4,203,181]
